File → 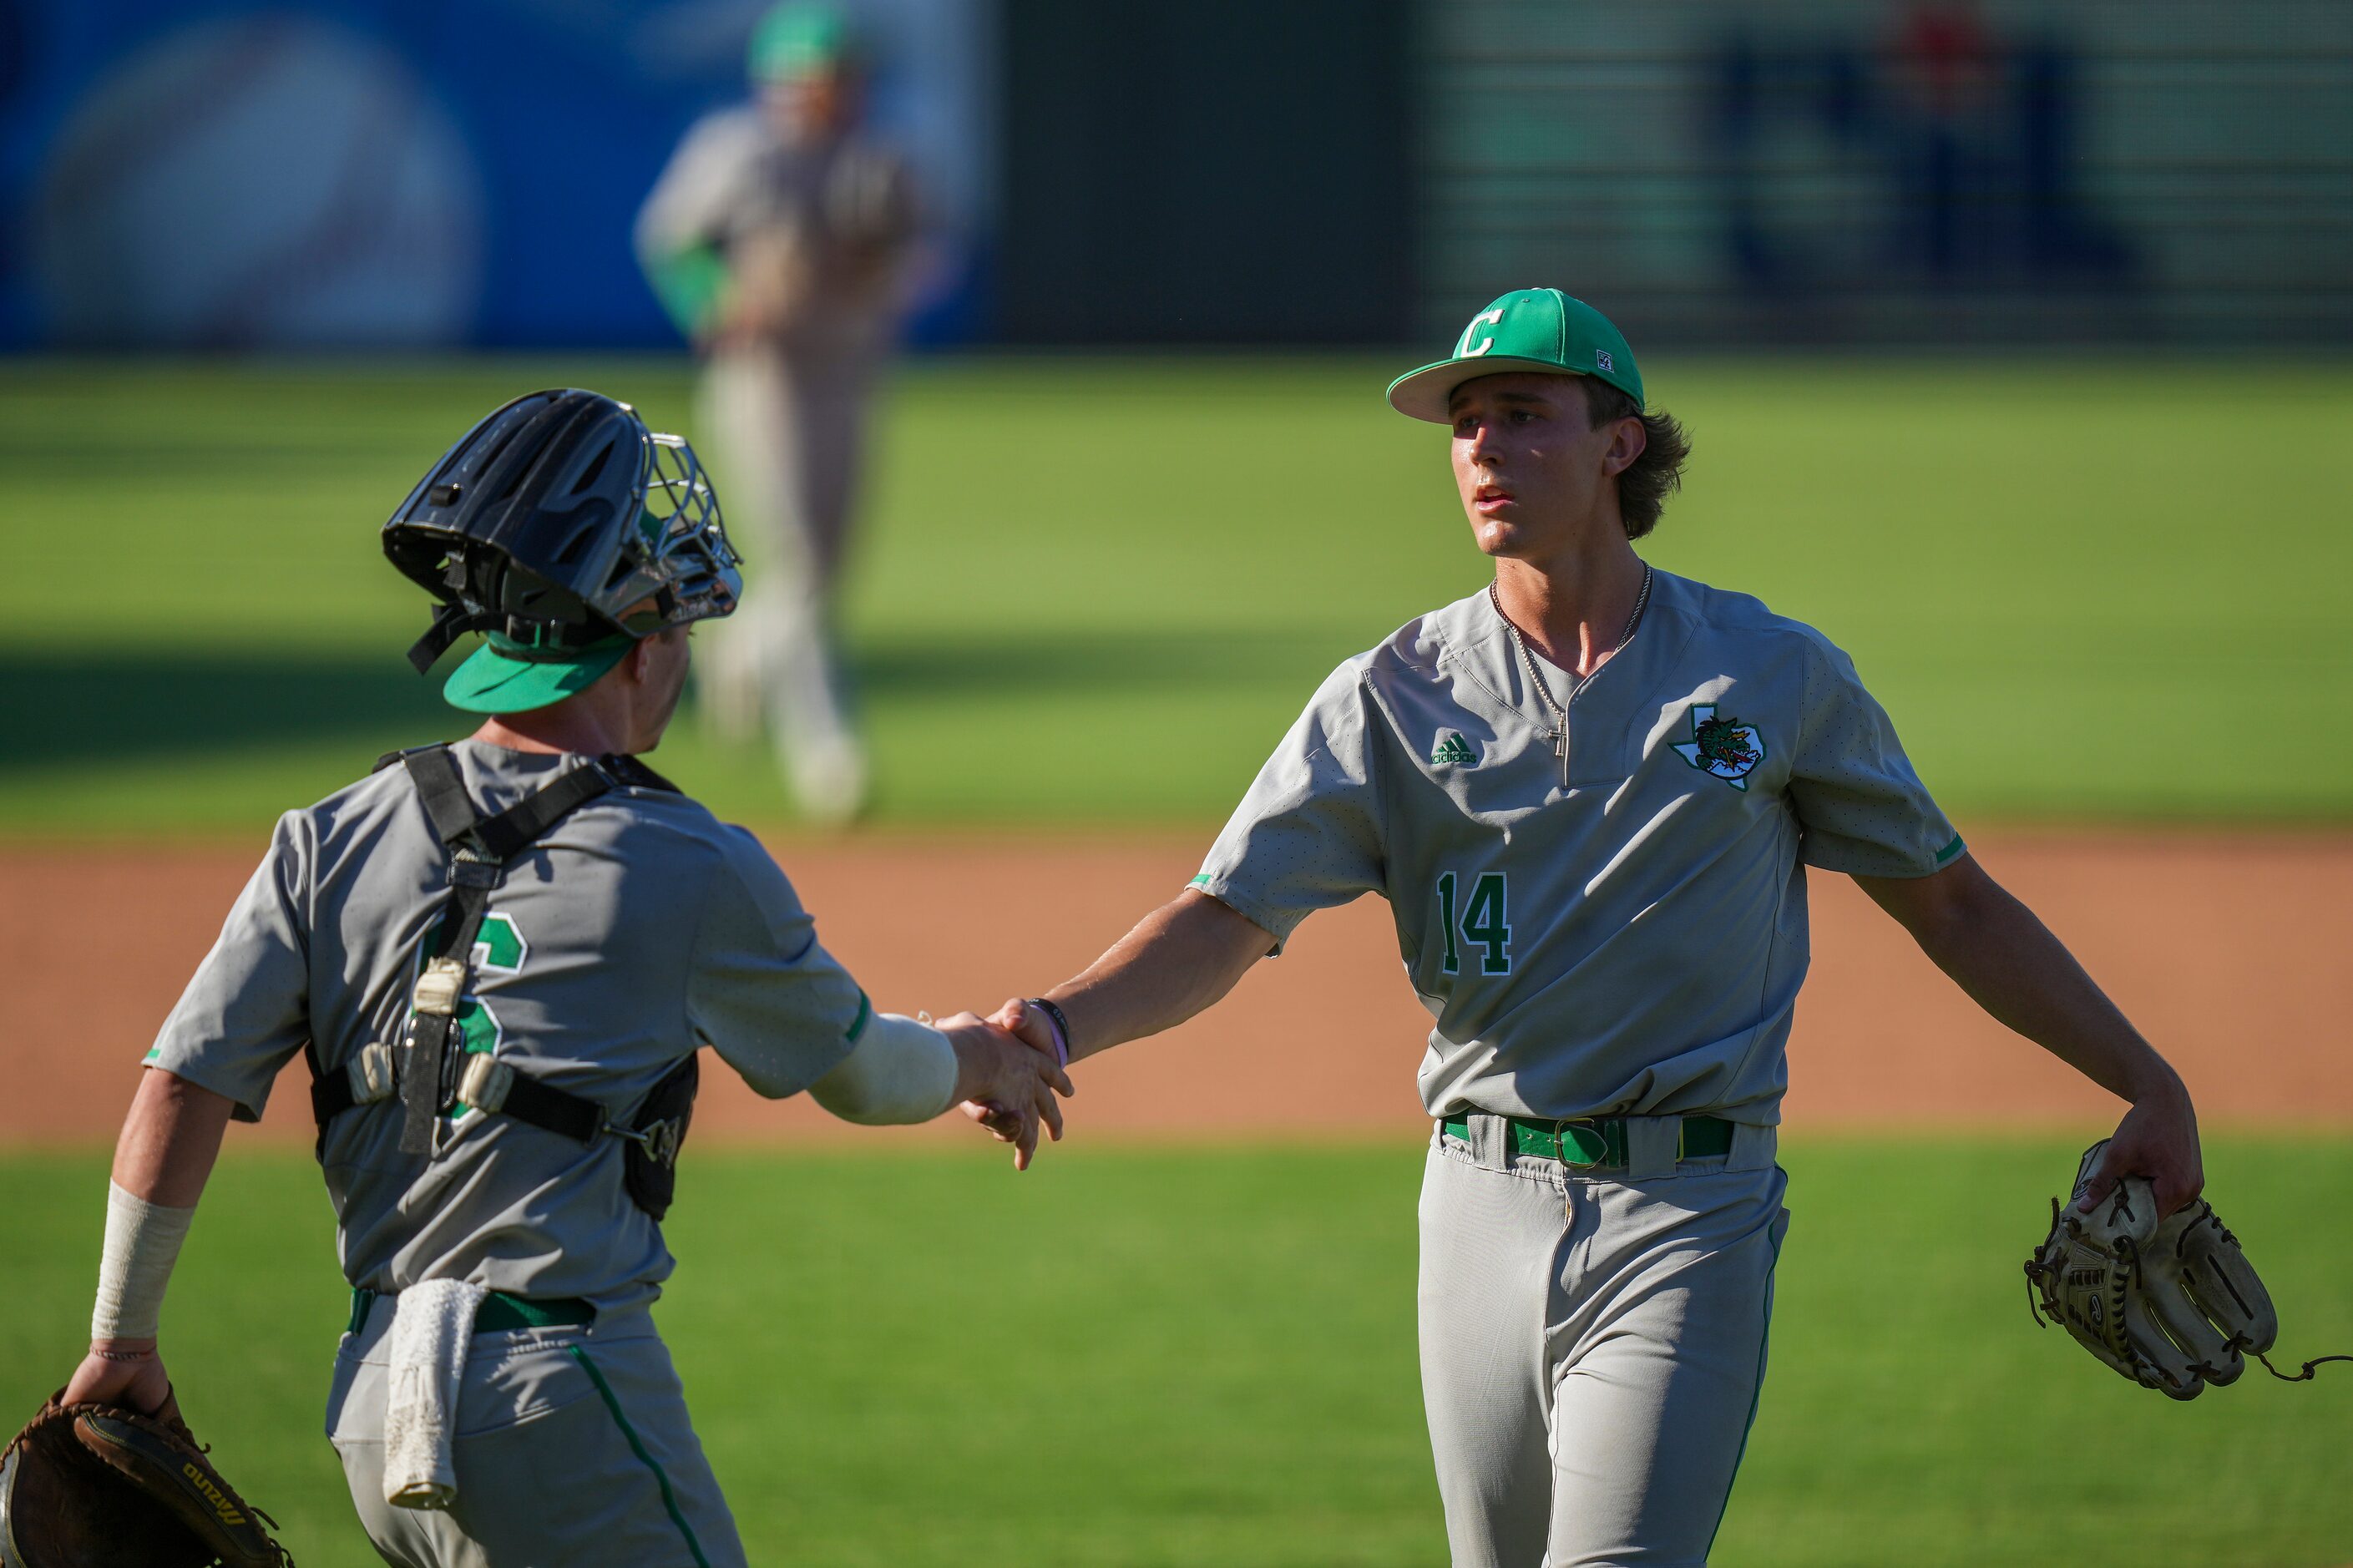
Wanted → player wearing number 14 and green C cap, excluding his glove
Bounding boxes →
[995,290,2203,1568]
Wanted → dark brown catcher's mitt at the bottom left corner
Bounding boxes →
[0,1399,294,1568]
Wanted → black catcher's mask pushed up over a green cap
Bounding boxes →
[383,388,743,713]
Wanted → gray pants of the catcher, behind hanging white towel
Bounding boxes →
[327,1297,743,1568]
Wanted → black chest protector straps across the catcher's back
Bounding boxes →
[304,746,699,1220]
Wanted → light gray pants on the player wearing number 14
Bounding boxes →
[1421,1116,1789,1568]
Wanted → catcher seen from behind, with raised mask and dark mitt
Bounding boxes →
[5,391,1068,1568]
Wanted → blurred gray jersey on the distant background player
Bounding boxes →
[638,106,918,360]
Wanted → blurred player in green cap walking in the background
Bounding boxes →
[638,5,918,824]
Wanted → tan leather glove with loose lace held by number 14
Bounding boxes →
[2026,1140,2348,1399]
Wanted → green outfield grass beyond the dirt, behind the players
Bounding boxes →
[0,353,2353,836]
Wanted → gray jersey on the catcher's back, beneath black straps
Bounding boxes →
[146,741,868,1309]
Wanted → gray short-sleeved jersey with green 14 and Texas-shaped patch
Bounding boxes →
[1193,572,1962,1123]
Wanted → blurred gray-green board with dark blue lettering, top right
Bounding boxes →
[1416,0,2353,348]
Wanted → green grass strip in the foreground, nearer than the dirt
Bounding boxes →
[0,1137,2353,1568]
